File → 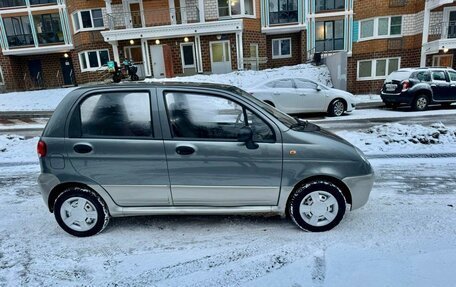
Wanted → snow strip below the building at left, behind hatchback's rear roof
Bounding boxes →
[0,88,75,112]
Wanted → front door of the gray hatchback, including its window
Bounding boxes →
[158,89,282,206]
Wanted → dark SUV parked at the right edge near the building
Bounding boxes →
[381,68,456,111]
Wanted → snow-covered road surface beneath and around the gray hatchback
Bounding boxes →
[0,158,456,286]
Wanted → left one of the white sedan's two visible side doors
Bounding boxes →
[271,79,300,113]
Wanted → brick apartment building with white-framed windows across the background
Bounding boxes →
[0,0,456,93]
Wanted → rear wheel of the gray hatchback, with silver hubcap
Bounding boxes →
[53,187,110,237]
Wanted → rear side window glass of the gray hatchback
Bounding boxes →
[80,92,152,138]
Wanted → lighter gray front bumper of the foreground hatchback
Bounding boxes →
[342,173,375,210]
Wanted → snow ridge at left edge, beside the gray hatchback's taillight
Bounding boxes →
[0,134,38,164]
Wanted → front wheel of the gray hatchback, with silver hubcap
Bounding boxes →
[288,180,347,232]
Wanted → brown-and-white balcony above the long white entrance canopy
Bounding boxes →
[108,6,200,30]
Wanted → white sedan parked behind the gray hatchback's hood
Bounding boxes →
[248,78,356,117]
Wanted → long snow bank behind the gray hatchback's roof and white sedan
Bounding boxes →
[145,64,332,89]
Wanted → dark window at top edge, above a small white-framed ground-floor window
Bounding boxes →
[269,0,298,24]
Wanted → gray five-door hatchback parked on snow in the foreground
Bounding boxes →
[38,82,374,236]
